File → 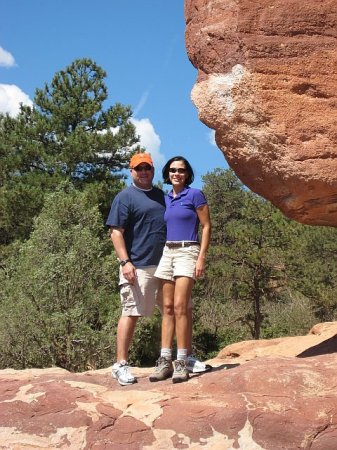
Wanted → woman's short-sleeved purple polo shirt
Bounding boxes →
[164,186,207,242]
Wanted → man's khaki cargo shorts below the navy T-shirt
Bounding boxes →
[119,266,162,317]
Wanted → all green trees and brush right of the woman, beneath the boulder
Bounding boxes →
[194,169,337,354]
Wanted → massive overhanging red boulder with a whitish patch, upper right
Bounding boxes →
[185,0,337,226]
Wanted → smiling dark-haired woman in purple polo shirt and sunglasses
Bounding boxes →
[150,156,211,383]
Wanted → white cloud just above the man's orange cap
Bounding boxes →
[131,118,165,172]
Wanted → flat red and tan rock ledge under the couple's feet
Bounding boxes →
[0,323,337,450]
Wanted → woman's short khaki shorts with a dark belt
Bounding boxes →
[154,245,200,281]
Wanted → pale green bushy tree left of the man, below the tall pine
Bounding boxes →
[0,185,119,370]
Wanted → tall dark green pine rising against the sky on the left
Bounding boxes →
[0,59,138,245]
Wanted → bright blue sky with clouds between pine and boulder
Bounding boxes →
[0,0,228,188]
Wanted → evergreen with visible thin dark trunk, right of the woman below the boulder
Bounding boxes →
[227,193,290,339]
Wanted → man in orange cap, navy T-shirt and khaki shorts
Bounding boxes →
[106,153,209,386]
